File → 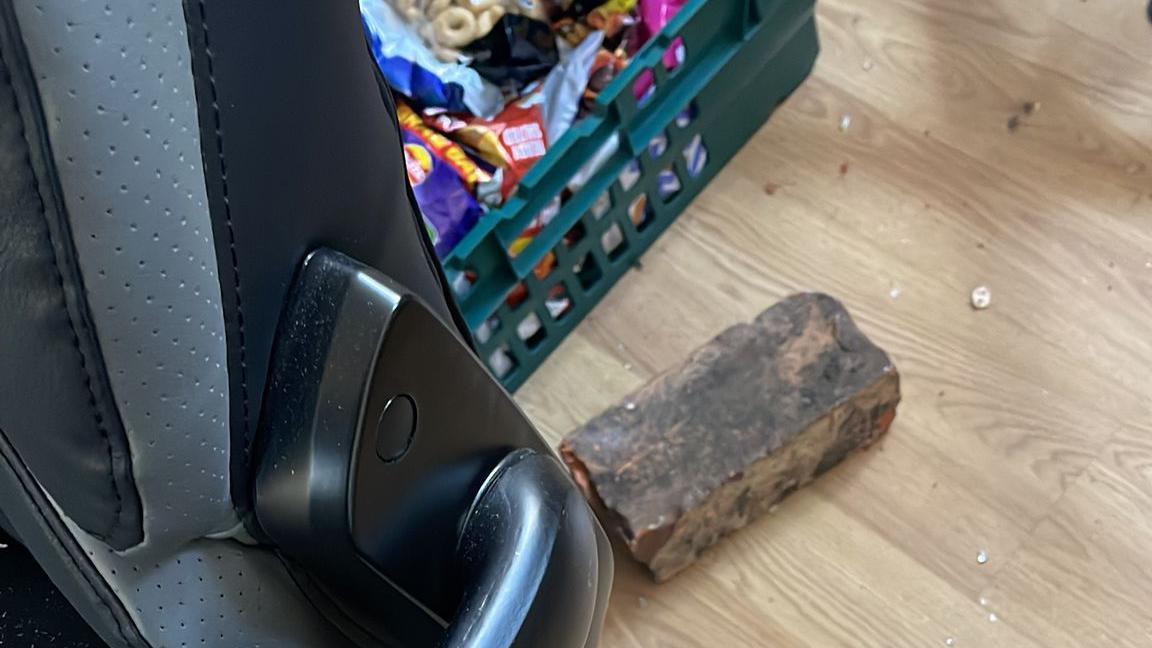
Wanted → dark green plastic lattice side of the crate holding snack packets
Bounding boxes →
[444,0,819,390]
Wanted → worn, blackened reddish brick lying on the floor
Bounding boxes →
[560,293,900,581]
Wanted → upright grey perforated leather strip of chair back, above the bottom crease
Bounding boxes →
[15,0,235,547]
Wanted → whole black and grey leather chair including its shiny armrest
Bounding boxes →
[0,0,612,647]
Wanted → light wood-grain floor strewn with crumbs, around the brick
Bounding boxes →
[518,0,1152,648]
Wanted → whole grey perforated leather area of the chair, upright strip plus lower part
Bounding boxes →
[14,0,344,648]
